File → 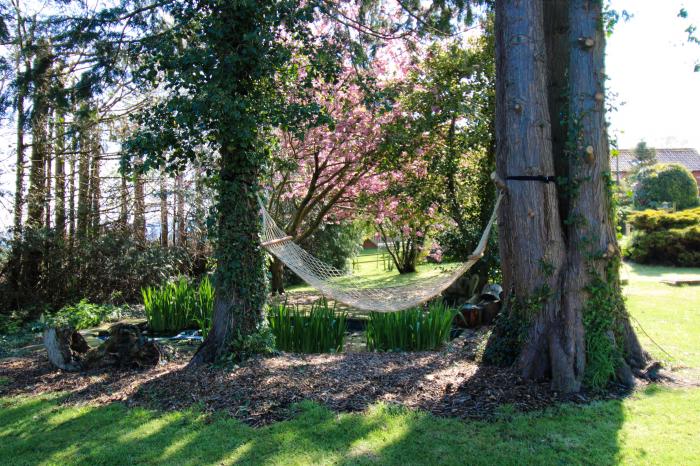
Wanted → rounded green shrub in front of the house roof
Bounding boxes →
[634,163,698,210]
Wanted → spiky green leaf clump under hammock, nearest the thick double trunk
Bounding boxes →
[366,302,457,351]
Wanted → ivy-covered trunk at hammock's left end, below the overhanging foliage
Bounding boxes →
[190,143,267,365]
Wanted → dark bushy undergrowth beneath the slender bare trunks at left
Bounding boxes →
[0,229,201,317]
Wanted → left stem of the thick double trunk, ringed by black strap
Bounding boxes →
[496,0,578,391]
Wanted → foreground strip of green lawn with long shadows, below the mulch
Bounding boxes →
[0,387,700,465]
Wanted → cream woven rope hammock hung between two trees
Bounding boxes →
[260,193,503,312]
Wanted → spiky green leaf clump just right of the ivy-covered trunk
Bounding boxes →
[267,299,347,353]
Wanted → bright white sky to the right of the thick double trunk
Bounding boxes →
[606,0,700,150]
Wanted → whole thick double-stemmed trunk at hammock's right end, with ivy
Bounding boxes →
[486,0,647,393]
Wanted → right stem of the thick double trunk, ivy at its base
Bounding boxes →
[563,0,648,385]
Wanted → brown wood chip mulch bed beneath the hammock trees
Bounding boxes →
[0,351,636,425]
